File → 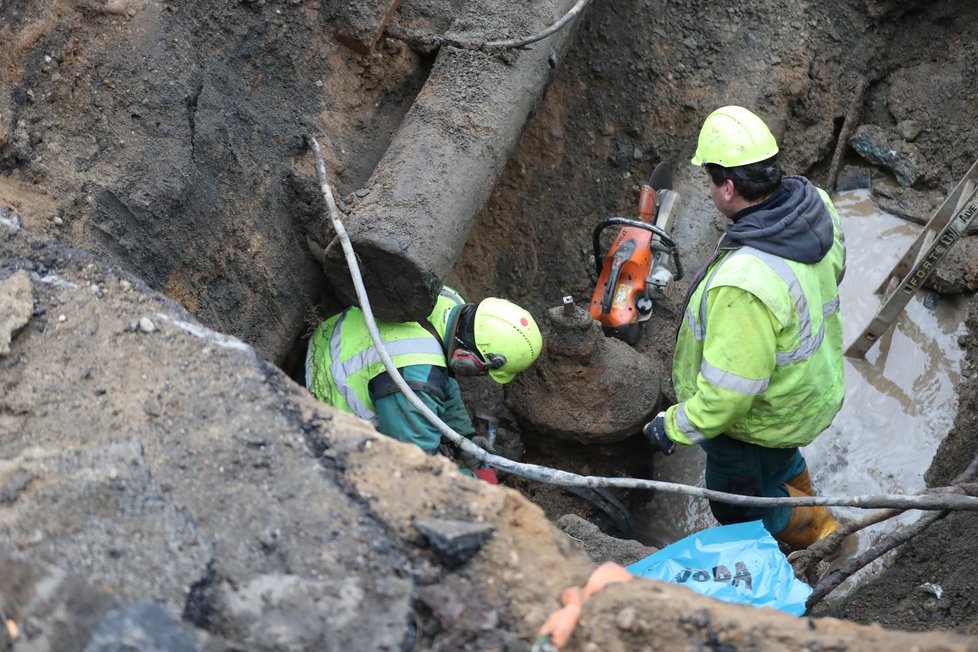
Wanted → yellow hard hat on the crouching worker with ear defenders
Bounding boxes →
[473,297,543,383]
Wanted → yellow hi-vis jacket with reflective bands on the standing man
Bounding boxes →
[666,190,845,448]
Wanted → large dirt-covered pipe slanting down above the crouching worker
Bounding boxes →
[323,0,579,321]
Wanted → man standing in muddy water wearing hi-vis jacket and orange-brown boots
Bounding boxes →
[644,106,846,550]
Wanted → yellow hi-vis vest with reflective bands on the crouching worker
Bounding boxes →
[306,286,465,426]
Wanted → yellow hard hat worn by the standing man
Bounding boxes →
[692,106,778,168]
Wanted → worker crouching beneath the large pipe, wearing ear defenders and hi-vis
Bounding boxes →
[306,286,543,484]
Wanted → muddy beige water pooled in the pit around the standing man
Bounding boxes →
[635,191,965,598]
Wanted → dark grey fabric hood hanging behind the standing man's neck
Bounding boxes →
[720,176,835,264]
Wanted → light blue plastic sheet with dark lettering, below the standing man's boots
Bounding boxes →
[628,521,812,616]
